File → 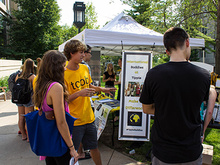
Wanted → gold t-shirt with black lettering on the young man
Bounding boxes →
[64,64,95,126]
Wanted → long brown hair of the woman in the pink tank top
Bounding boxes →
[34,50,68,107]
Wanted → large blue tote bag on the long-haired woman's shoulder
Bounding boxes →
[25,111,76,157]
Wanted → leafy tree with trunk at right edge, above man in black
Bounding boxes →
[176,0,220,75]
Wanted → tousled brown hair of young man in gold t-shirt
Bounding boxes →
[64,40,86,61]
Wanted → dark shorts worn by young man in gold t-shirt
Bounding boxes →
[72,122,98,150]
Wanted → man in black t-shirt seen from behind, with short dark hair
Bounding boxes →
[140,27,210,165]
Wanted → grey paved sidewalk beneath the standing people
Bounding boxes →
[0,100,146,165]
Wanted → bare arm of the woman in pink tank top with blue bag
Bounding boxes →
[48,83,78,162]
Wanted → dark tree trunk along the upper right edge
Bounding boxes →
[215,0,220,76]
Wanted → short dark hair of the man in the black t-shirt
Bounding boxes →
[163,27,189,52]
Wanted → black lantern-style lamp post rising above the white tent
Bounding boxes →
[73,2,86,33]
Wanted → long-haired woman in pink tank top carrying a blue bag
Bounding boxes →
[34,50,78,165]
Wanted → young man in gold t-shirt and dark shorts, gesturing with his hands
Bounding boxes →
[64,40,116,165]
